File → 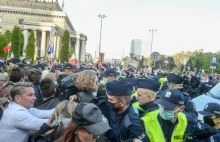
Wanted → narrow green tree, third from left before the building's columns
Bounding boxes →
[26,31,35,61]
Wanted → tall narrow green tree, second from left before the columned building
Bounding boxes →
[10,26,21,58]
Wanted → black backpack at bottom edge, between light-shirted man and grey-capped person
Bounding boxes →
[31,122,64,142]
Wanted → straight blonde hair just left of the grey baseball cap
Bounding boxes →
[48,100,77,126]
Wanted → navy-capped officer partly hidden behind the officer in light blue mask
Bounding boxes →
[162,73,198,119]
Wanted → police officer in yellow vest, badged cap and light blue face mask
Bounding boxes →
[142,89,219,142]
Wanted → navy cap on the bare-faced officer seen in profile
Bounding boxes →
[137,79,160,92]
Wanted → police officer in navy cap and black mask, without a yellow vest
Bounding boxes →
[97,80,148,142]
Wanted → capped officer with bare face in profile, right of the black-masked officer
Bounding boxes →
[137,79,160,119]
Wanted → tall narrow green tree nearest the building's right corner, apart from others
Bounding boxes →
[60,30,70,63]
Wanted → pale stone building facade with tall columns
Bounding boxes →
[0,0,87,63]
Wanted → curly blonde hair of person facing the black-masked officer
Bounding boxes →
[75,70,99,92]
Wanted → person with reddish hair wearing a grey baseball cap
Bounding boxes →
[56,103,110,142]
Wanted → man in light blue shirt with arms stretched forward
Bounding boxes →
[0,82,53,142]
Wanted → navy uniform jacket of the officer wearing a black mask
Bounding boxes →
[97,100,147,142]
